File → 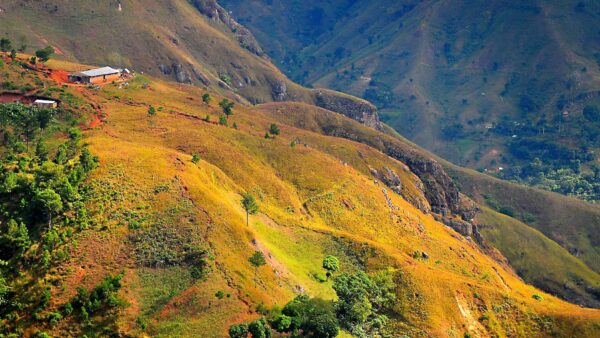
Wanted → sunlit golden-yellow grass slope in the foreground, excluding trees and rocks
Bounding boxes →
[25,61,600,337]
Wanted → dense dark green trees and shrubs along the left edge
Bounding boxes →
[0,104,98,333]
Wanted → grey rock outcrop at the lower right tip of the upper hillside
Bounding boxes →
[315,89,383,131]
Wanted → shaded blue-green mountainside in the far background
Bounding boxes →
[221,0,600,200]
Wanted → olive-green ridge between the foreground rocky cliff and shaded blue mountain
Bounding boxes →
[256,103,600,306]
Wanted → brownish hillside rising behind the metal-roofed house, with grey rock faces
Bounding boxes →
[0,0,381,128]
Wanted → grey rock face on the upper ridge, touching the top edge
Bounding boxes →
[192,0,266,57]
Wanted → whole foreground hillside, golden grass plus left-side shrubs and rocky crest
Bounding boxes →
[0,56,600,337]
